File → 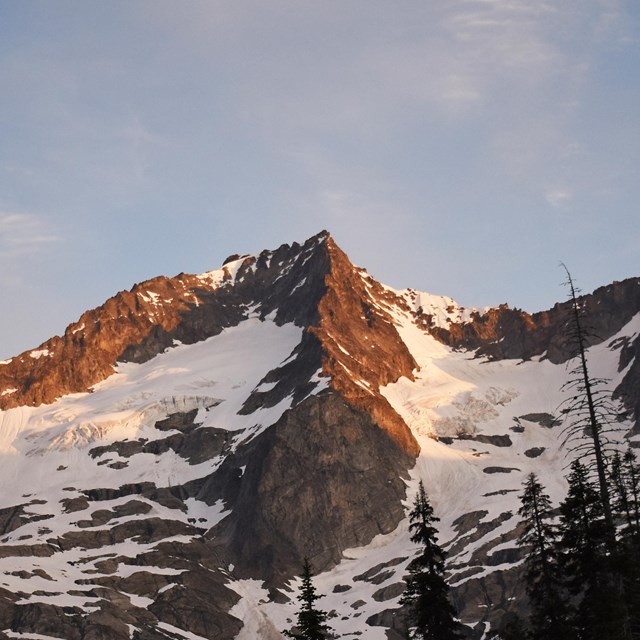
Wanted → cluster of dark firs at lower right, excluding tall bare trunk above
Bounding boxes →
[512,448,640,640]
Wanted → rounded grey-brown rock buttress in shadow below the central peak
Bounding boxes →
[210,392,413,583]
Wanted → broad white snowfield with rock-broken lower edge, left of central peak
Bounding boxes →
[0,318,302,616]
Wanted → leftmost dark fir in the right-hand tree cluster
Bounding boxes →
[518,473,572,640]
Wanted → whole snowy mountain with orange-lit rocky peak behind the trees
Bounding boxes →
[0,232,640,640]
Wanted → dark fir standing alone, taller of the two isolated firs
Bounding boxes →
[400,482,461,640]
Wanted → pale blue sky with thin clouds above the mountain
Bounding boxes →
[0,0,640,357]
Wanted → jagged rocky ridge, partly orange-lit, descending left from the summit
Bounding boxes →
[0,232,329,408]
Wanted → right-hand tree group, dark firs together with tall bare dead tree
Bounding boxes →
[502,265,640,640]
